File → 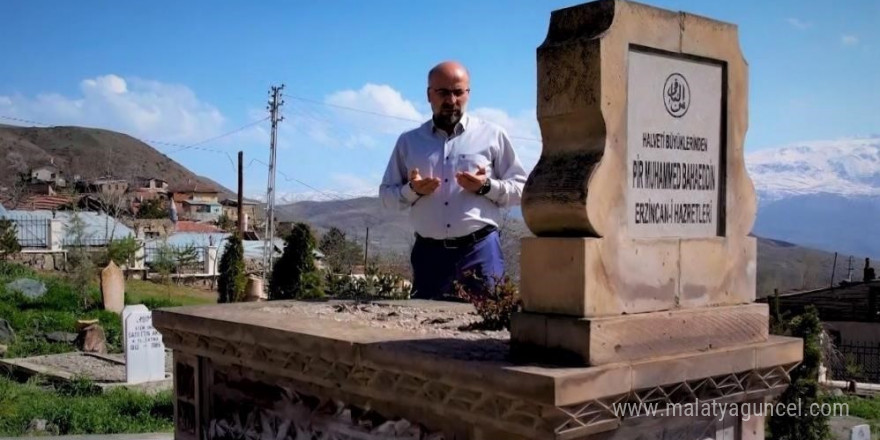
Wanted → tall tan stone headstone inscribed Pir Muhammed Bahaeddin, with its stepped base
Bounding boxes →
[511,0,769,365]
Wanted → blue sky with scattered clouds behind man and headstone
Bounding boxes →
[0,0,880,199]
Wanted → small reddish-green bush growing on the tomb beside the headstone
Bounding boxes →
[454,272,522,330]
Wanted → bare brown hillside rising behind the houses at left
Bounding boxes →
[0,125,233,199]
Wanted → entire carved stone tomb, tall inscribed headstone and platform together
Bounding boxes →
[153,0,803,440]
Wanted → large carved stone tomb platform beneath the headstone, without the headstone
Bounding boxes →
[153,301,802,440]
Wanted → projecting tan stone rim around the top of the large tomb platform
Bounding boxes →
[153,306,802,406]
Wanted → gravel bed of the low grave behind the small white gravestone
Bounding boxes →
[23,350,173,382]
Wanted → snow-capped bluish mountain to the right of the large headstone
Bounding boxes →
[746,136,880,257]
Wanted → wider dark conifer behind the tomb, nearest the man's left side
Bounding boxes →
[269,223,324,300]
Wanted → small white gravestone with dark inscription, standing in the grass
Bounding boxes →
[122,305,165,383]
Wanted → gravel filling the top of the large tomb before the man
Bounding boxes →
[260,301,510,340]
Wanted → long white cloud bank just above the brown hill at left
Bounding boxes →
[0,74,228,143]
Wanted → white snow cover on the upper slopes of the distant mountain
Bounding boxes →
[746,136,880,204]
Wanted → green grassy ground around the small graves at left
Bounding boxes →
[0,262,216,437]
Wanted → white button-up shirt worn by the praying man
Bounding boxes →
[379,114,528,239]
